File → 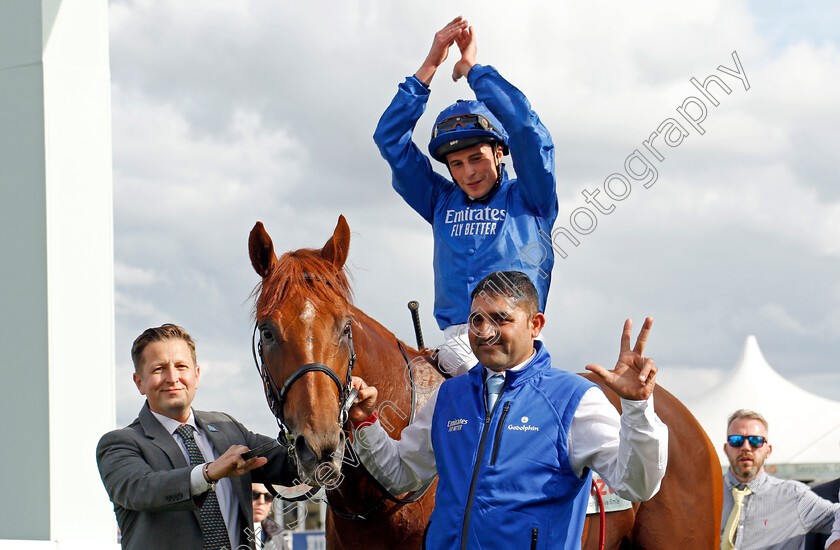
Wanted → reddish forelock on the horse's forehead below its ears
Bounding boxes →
[253,248,353,318]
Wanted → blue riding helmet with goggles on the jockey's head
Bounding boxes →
[429,99,508,164]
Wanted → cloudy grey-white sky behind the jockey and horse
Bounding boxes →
[110,0,840,440]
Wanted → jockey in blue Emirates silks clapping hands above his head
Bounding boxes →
[373,17,558,380]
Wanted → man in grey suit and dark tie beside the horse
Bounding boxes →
[96,324,298,550]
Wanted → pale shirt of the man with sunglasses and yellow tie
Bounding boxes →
[721,470,840,550]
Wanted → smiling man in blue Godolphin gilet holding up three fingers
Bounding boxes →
[350,272,668,550]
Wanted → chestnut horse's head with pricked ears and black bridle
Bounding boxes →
[248,216,352,485]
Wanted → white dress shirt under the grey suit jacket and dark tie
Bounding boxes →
[151,409,239,548]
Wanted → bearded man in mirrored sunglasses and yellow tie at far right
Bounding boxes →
[720,409,840,550]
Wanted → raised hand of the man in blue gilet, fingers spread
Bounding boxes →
[586,317,656,401]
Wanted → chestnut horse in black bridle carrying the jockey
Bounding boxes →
[248,216,723,550]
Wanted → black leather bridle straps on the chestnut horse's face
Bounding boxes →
[251,321,359,450]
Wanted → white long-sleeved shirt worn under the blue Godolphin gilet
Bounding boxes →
[353,355,668,501]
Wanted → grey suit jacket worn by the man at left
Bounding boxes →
[96,403,297,550]
